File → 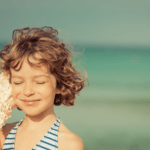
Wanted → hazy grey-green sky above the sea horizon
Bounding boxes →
[0,0,150,47]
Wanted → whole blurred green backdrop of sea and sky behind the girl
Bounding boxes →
[0,0,150,150]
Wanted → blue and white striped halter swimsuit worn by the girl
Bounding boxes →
[3,117,60,150]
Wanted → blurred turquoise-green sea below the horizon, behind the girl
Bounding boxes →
[0,43,150,150]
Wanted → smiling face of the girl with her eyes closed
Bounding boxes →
[11,55,60,116]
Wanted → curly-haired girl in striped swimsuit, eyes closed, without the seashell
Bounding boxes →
[0,27,87,150]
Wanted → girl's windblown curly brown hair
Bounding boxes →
[0,26,87,110]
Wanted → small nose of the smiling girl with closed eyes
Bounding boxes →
[23,83,35,97]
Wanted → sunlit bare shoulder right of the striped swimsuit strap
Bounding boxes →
[58,122,84,150]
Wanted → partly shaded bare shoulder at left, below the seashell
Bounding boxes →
[0,122,18,149]
